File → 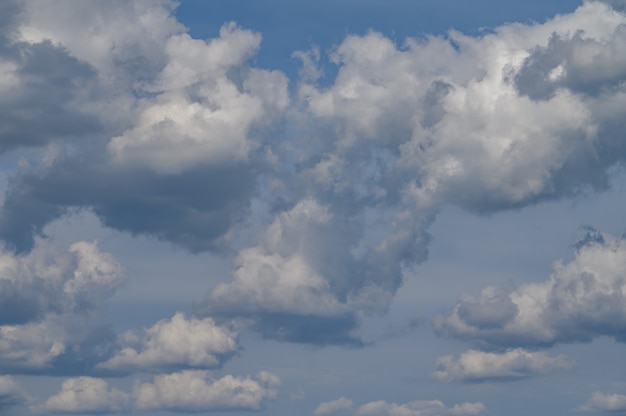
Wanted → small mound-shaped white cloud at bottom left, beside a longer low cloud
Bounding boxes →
[41,377,130,414]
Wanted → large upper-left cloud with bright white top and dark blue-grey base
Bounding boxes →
[0,1,289,251]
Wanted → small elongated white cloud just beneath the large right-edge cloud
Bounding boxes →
[431,348,573,382]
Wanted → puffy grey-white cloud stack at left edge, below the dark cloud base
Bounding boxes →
[0,237,125,372]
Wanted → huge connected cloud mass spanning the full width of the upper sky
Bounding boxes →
[0,0,626,345]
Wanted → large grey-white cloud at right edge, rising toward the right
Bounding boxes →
[434,230,626,347]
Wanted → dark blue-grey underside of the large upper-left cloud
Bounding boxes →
[0,158,256,252]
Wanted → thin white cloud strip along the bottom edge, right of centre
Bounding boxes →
[356,400,485,416]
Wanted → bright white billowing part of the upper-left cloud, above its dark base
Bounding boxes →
[108,23,289,173]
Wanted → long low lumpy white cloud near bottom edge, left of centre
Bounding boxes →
[134,370,280,412]
